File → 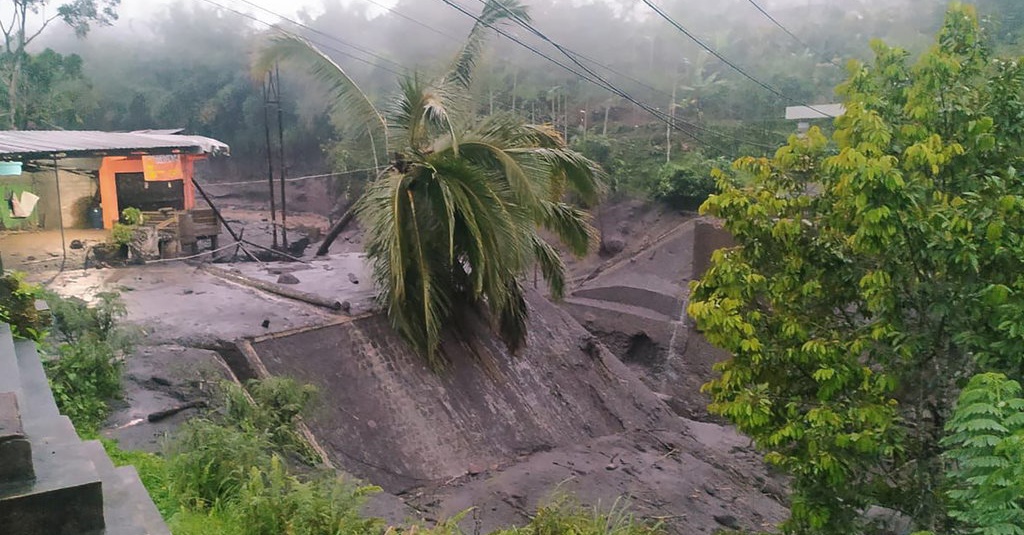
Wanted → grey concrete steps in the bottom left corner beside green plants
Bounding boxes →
[0,324,170,535]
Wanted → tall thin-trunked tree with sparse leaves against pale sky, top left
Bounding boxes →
[0,0,121,129]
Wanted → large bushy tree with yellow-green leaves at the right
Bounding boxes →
[689,5,1024,534]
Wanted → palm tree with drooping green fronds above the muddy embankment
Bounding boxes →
[257,0,601,366]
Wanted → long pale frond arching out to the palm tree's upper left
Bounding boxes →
[252,33,389,168]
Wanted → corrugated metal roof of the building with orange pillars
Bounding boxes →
[0,130,229,160]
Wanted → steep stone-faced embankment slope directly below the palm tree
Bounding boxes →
[245,294,678,492]
